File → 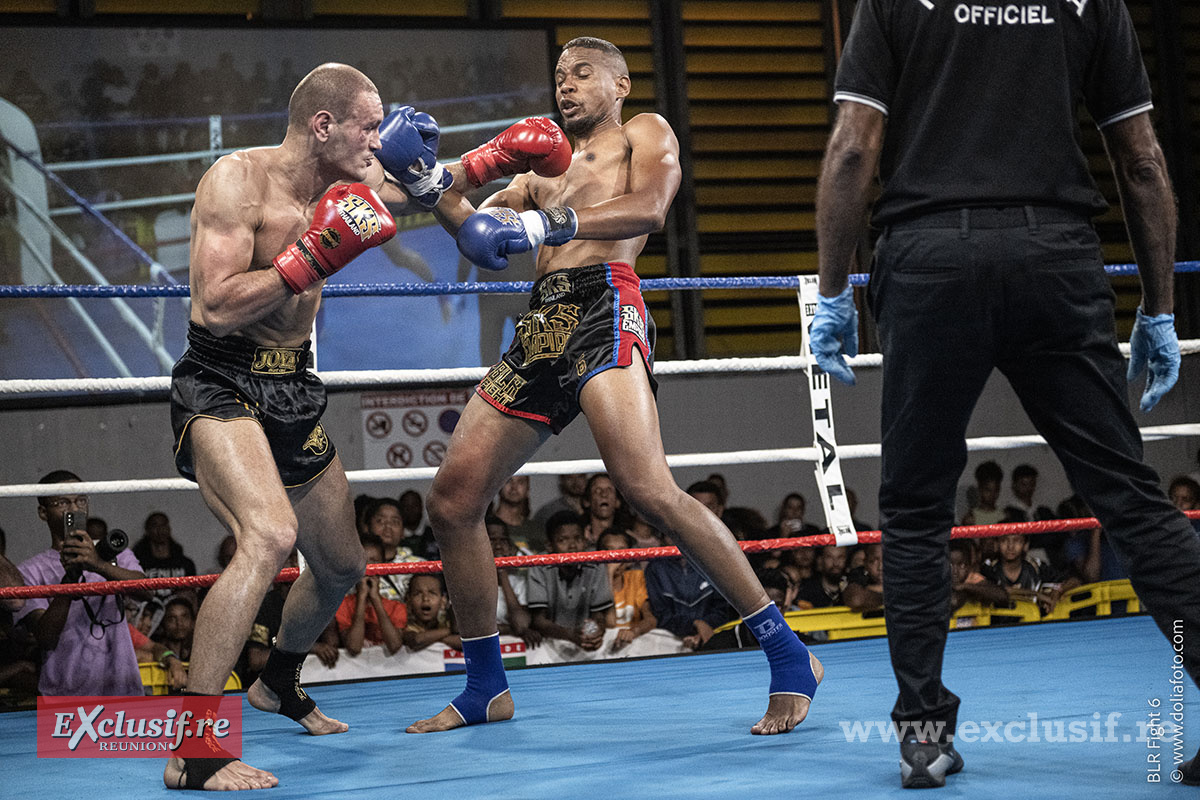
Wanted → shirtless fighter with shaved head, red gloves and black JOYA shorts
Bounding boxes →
[163,64,427,789]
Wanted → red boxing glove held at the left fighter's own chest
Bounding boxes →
[271,184,396,294]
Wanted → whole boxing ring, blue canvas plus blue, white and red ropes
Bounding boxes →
[0,130,1200,800]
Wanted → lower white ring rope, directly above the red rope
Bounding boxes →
[0,423,1200,498]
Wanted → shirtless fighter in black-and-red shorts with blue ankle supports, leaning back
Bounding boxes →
[379,37,823,734]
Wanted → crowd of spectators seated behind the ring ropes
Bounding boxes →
[0,461,1200,697]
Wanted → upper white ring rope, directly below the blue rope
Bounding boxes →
[0,339,1200,396]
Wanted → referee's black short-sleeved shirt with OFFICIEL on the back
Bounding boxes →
[834,0,1151,224]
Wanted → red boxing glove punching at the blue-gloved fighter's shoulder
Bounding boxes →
[462,116,571,186]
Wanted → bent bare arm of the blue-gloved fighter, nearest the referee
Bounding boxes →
[575,114,682,241]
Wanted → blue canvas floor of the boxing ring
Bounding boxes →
[0,616,1200,800]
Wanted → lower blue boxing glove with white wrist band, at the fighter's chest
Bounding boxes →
[457,206,580,270]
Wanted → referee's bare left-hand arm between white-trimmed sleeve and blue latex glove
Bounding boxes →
[817,101,886,297]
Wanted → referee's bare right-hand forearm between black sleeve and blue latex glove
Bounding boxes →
[1102,112,1177,315]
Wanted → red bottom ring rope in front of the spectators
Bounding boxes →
[0,511,1180,600]
